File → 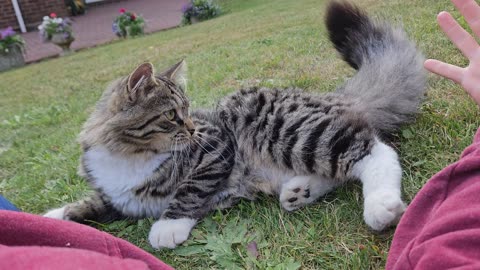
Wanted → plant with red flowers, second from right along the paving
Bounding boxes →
[112,8,145,38]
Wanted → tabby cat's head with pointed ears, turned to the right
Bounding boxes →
[106,61,195,153]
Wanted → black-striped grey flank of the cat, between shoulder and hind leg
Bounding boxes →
[218,88,375,181]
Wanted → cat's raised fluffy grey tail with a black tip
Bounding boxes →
[326,2,426,134]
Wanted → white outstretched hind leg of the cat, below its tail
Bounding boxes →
[353,141,406,231]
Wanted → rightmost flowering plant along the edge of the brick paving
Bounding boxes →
[182,0,221,25]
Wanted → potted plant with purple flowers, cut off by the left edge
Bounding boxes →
[0,27,25,71]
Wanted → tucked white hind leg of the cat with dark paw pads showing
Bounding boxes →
[280,175,338,211]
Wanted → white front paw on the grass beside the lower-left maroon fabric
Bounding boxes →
[148,218,196,248]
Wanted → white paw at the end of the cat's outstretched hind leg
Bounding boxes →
[363,191,406,231]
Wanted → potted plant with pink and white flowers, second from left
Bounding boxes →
[38,13,75,55]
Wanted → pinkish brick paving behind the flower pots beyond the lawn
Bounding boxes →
[22,0,187,63]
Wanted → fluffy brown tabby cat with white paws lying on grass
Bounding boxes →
[45,2,425,248]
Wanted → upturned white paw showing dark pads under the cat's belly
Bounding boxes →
[280,179,316,211]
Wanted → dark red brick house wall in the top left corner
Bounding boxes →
[0,0,68,29]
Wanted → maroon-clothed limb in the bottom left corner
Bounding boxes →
[0,210,173,270]
